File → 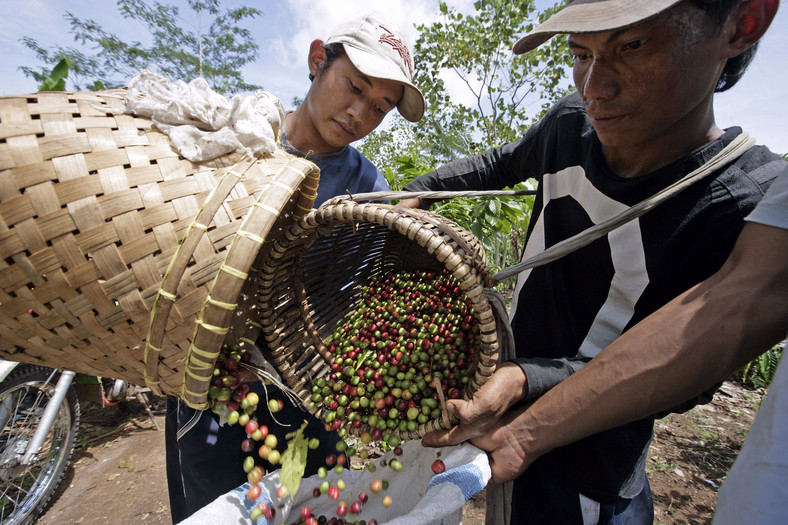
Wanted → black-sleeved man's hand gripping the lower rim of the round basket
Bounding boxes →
[422,363,527,448]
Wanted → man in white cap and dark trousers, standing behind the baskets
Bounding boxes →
[165,13,424,523]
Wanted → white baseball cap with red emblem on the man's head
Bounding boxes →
[326,12,426,122]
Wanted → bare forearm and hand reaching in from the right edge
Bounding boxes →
[472,219,788,481]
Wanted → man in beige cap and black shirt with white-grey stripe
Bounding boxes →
[405,0,786,524]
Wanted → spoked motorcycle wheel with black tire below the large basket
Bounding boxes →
[0,364,79,525]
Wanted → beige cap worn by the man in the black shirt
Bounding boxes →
[514,0,681,55]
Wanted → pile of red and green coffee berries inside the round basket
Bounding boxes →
[311,269,480,441]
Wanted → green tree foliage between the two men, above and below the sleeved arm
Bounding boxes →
[359,0,571,276]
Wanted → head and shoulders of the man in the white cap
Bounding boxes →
[280,13,424,204]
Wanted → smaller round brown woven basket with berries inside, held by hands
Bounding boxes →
[257,201,499,439]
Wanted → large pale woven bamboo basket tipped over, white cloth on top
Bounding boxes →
[0,90,319,408]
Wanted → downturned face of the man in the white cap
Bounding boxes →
[308,55,404,152]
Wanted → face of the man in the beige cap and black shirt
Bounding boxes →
[569,7,724,148]
